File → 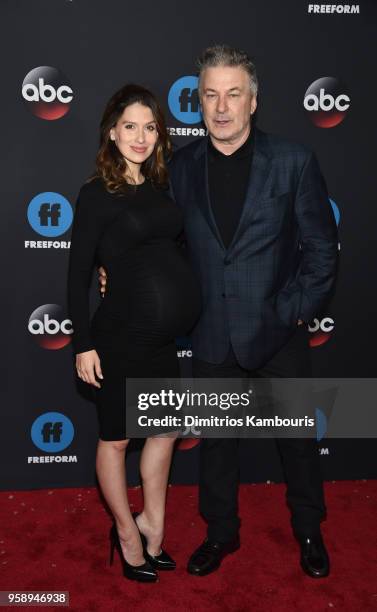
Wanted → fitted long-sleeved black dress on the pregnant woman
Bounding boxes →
[68,178,200,440]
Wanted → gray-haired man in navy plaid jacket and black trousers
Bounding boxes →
[100,45,338,578]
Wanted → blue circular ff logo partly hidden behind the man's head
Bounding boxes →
[168,76,202,124]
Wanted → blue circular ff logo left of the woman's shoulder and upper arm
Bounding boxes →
[27,191,73,237]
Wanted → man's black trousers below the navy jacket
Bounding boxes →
[193,324,326,542]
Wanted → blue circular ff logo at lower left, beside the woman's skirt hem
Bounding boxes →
[31,412,75,453]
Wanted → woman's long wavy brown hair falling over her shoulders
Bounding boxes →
[92,84,172,193]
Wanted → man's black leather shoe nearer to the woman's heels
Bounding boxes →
[187,538,240,576]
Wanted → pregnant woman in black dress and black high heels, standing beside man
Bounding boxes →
[68,85,200,582]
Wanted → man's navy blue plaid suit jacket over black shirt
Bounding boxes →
[170,128,338,369]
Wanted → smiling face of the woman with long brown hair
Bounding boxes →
[110,102,158,164]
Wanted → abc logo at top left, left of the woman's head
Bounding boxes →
[22,66,73,121]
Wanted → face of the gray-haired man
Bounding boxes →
[200,66,257,144]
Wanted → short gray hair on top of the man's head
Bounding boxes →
[197,45,258,96]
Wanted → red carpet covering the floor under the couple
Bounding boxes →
[0,481,377,612]
